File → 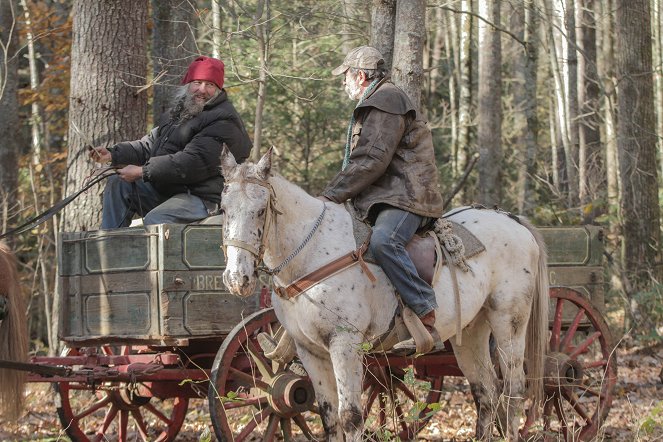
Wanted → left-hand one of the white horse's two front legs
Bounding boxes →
[297,346,343,442]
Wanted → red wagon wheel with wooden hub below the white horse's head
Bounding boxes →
[208,309,324,442]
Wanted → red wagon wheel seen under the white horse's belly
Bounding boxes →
[363,357,444,440]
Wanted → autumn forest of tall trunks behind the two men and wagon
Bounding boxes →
[0,0,663,372]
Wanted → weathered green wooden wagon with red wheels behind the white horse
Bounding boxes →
[19,224,617,441]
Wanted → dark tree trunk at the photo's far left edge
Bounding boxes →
[0,0,19,232]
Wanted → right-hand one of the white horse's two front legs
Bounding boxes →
[329,332,364,442]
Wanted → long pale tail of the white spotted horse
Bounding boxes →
[520,218,550,403]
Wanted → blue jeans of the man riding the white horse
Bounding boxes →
[370,207,437,317]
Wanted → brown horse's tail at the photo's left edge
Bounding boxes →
[0,241,28,420]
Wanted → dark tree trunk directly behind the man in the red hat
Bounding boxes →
[152,0,197,121]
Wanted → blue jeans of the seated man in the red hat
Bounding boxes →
[101,175,208,229]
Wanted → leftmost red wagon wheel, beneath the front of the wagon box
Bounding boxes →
[54,346,189,442]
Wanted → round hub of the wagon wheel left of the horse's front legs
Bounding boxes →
[268,373,315,417]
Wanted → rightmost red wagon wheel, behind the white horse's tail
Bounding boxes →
[521,287,617,441]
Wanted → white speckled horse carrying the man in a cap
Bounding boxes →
[221,149,548,441]
